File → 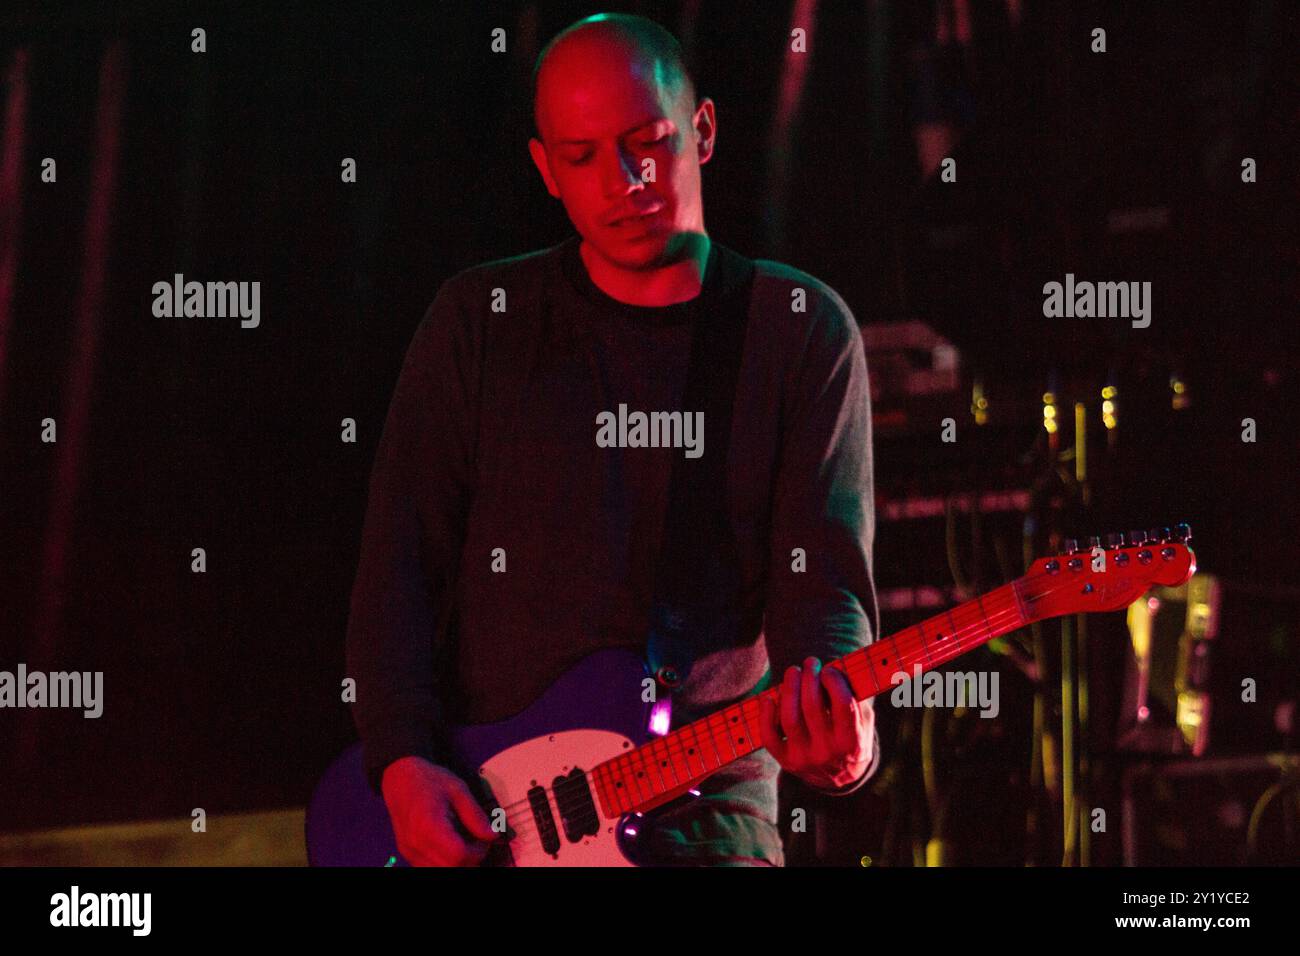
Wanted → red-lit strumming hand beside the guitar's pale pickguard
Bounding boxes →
[380,757,502,866]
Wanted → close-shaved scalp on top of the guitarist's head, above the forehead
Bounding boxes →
[533,13,696,140]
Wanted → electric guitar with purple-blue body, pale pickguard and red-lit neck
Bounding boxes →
[307,524,1196,866]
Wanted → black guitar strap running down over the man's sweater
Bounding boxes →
[646,243,754,698]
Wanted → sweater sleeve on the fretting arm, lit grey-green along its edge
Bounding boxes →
[764,286,880,795]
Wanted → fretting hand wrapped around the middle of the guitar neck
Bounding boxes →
[759,657,876,790]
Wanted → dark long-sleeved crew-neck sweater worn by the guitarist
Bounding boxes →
[347,235,879,862]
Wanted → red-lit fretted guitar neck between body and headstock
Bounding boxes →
[590,578,1030,817]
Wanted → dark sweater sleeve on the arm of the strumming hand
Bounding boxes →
[346,284,477,792]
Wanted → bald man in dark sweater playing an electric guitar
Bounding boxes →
[347,14,879,865]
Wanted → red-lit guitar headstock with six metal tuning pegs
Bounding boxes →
[1021,524,1196,620]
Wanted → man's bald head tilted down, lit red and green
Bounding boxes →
[528,13,715,269]
